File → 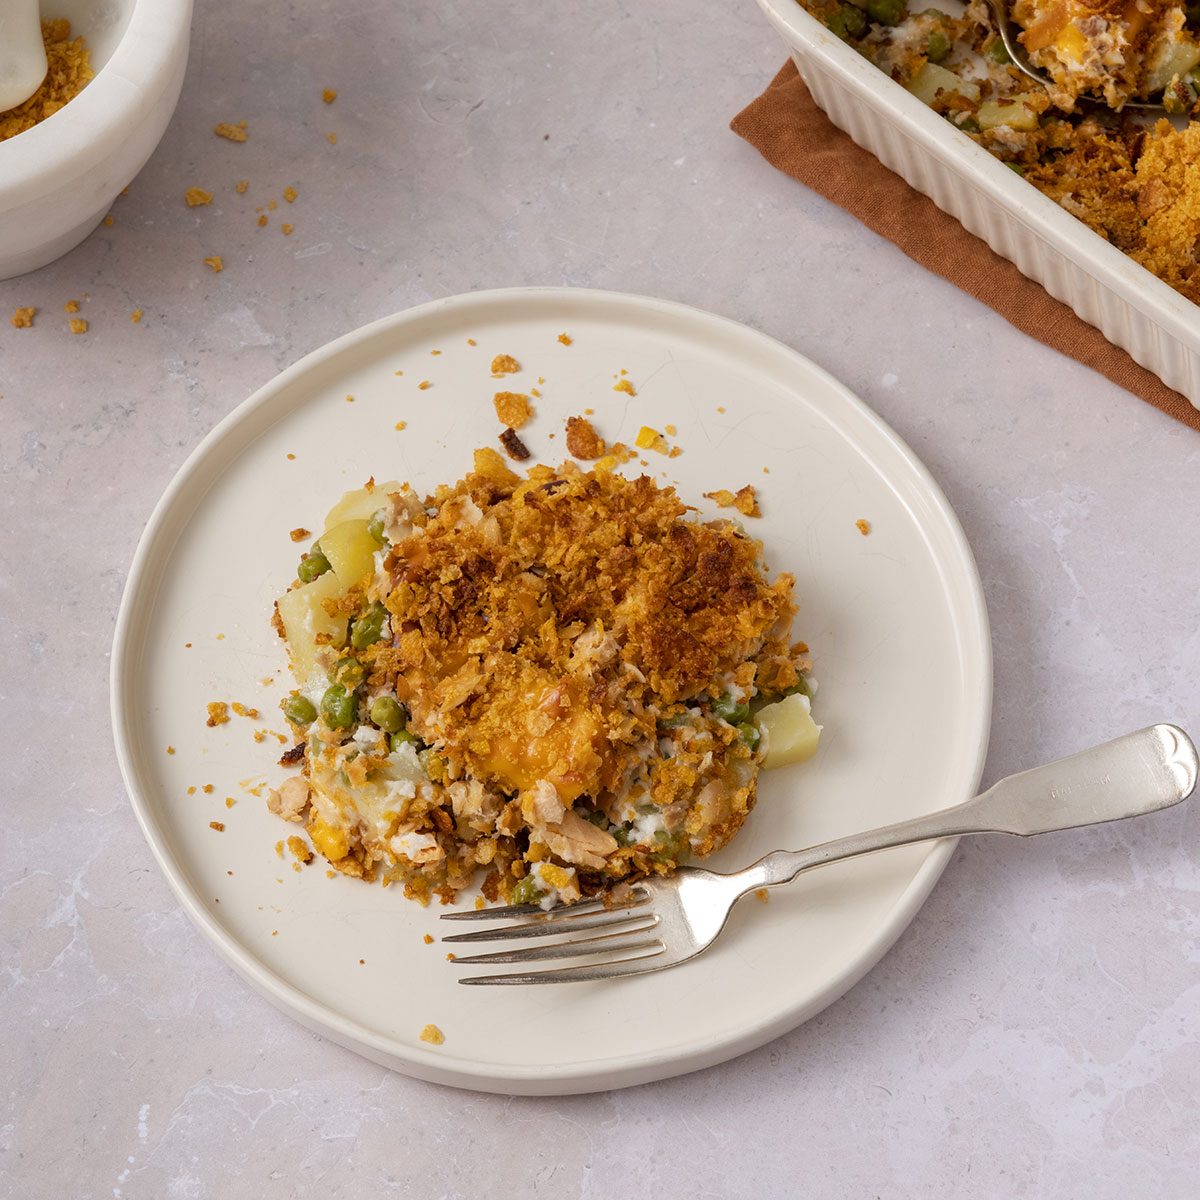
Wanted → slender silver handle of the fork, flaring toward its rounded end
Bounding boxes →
[737,725,1198,895]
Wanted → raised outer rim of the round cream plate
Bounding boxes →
[109,286,992,1096]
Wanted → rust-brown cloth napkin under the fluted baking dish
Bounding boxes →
[731,59,1200,431]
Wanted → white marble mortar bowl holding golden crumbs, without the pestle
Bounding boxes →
[0,0,192,280]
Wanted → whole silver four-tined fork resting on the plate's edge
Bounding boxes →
[442,725,1198,984]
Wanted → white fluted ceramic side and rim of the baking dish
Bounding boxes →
[758,0,1200,408]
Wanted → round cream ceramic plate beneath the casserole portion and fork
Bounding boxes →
[112,288,991,1094]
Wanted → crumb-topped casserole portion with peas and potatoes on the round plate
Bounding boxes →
[269,450,820,906]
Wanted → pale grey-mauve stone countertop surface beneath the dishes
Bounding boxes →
[0,0,1200,1200]
